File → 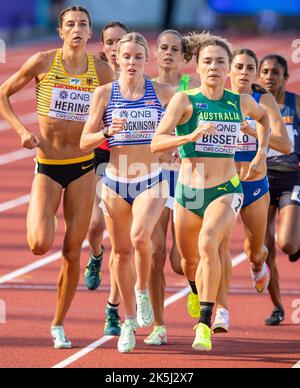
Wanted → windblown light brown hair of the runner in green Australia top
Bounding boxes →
[184,31,232,63]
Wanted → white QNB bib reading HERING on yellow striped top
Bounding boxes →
[49,88,92,122]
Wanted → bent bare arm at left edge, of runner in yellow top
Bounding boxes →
[0,53,49,149]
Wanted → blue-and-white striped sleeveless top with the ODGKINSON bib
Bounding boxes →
[103,80,163,148]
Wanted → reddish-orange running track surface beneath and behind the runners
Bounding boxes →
[0,35,300,368]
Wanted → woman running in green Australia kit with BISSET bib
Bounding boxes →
[152,34,270,351]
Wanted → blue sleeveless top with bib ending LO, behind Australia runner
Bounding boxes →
[234,92,262,162]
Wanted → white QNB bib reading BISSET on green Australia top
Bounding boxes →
[196,121,241,155]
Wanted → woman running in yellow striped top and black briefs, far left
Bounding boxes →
[0,7,113,349]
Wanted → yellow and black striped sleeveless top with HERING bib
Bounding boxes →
[36,49,99,122]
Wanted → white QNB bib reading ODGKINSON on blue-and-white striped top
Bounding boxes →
[112,109,158,142]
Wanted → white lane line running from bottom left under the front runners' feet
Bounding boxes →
[52,253,247,369]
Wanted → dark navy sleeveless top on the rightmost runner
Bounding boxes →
[267,92,300,171]
